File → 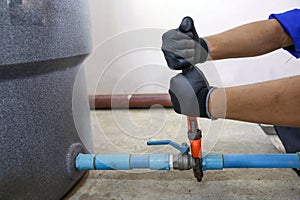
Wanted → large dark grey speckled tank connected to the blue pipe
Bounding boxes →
[0,0,92,200]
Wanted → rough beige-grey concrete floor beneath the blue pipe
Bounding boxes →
[65,109,300,200]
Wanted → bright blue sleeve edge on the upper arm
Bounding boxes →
[269,9,300,58]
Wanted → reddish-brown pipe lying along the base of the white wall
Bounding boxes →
[89,94,173,109]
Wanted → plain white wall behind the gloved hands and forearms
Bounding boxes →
[86,0,300,94]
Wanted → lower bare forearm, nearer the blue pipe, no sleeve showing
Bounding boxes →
[209,76,300,127]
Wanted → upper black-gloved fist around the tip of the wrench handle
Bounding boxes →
[162,17,209,70]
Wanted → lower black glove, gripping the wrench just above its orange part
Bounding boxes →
[169,67,213,118]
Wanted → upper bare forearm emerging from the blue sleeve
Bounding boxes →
[204,19,293,60]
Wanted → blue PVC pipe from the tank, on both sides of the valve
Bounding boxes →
[76,153,300,171]
